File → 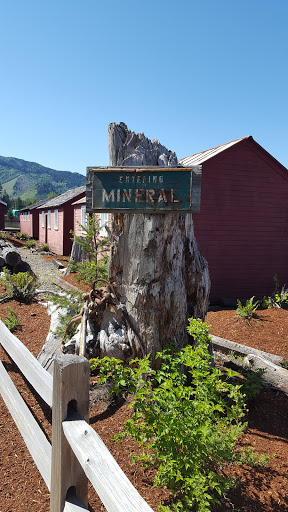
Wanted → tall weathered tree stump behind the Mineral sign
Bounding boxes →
[100,123,210,359]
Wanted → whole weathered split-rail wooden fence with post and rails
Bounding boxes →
[0,321,153,512]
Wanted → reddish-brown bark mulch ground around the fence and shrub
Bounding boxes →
[0,248,288,512]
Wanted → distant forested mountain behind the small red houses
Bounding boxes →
[0,156,86,200]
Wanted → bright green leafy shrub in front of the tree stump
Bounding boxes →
[90,319,264,512]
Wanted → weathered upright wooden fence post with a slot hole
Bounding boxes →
[50,355,90,512]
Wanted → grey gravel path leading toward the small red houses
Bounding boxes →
[17,247,61,291]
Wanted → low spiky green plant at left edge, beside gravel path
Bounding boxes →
[0,267,37,303]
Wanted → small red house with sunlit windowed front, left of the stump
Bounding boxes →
[37,185,86,256]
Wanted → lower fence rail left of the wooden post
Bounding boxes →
[0,362,51,489]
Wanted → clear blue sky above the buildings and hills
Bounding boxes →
[0,0,288,174]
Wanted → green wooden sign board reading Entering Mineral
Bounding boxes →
[86,165,202,213]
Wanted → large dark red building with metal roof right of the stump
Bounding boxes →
[179,136,288,305]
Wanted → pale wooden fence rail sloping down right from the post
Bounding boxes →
[62,413,153,512]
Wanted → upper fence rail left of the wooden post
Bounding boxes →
[0,321,53,407]
